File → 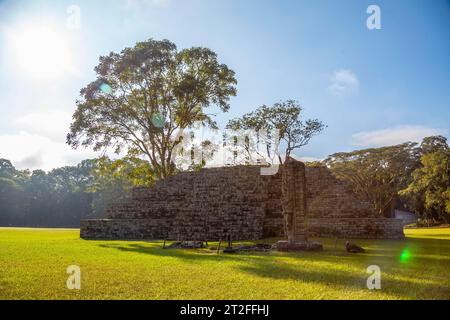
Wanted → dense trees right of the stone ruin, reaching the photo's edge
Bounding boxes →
[323,136,450,222]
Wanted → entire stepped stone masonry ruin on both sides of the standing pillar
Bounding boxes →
[80,166,403,240]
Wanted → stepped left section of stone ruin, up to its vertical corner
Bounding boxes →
[81,166,268,240]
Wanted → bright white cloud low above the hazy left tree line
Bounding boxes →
[0,131,96,171]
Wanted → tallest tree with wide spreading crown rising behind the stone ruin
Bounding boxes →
[67,39,237,178]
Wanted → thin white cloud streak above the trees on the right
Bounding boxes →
[352,125,446,147]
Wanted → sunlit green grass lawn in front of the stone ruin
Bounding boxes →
[0,228,450,299]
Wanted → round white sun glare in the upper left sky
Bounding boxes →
[12,27,72,78]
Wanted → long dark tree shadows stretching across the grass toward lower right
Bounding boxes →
[99,238,450,299]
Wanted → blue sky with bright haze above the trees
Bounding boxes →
[0,0,450,169]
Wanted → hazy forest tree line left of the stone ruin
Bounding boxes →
[0,157,152,228]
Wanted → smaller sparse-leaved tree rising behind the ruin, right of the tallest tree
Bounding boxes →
[227,100,325,164]
